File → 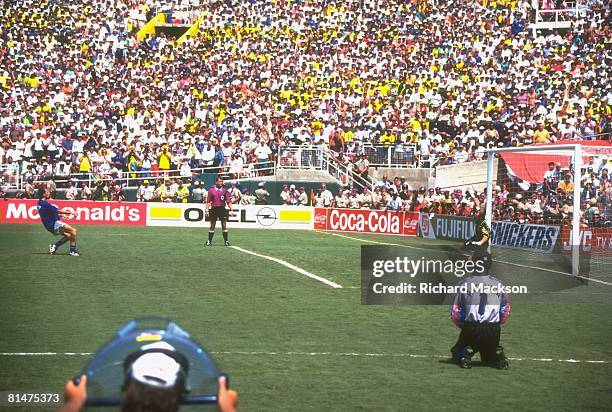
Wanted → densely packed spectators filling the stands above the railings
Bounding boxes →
[0,0,612,212]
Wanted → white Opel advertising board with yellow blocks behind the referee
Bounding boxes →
[147,203,313,230]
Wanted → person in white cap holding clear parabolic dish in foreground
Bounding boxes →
[59,316,238,412]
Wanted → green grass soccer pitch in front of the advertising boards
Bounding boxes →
[0,225,612,411]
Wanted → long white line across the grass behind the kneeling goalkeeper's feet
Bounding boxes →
[0,351,612,364]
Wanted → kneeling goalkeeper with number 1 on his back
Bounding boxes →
[451,255,510,369]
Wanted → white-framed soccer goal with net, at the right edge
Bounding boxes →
[485,141,612,291]
